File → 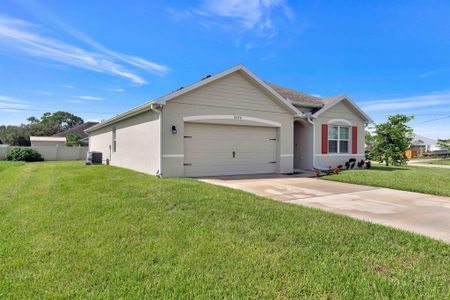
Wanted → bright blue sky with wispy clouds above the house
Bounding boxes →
[0,0,450,138]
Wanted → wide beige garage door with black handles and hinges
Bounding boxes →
[184,123,278,177]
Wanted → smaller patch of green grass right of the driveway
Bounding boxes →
[323,165,450,196]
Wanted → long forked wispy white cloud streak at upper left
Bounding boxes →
[0,17,168,87]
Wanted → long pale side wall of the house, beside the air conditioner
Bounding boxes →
[89,111,160,175]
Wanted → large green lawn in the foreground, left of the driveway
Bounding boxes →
[0,162,450,299]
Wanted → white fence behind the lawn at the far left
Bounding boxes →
[0,145,89,160]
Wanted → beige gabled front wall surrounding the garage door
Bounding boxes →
[163,73,294,177]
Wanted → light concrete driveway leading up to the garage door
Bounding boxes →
[201,175,450,243]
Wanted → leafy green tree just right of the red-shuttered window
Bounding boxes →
[371,114,414,166]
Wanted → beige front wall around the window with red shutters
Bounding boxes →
[314,100,365,168]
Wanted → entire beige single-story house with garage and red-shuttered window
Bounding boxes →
[86,65,372,177]
